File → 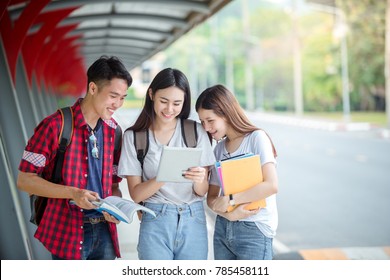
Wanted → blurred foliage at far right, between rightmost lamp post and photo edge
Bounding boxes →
[336,0,386,111]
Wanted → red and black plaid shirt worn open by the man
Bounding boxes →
[19,99,121,259]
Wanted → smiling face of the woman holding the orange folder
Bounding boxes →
[198,109,228,141]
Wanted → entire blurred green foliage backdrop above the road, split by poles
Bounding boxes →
[160,0,386,112]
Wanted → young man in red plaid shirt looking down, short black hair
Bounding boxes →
[17,56,132,260]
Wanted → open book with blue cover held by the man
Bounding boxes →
[71,196,156,224]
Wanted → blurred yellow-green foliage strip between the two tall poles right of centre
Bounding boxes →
[301,12,342,112]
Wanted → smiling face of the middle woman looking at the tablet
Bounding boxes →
[149,87,184,123]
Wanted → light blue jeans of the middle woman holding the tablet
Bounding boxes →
[137,201,208,260]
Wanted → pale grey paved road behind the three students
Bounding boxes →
[112,110,390,259]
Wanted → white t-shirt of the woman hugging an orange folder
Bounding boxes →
[210,130,278,238]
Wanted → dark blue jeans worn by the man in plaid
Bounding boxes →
[52,223,116,260]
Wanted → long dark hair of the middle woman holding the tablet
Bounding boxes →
[128,68,191,131]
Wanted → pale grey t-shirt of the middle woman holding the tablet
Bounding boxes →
[118,119,215,205]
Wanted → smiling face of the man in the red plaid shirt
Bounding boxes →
[89,78,128,120]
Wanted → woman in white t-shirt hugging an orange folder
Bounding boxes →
[195,85,278,260]
